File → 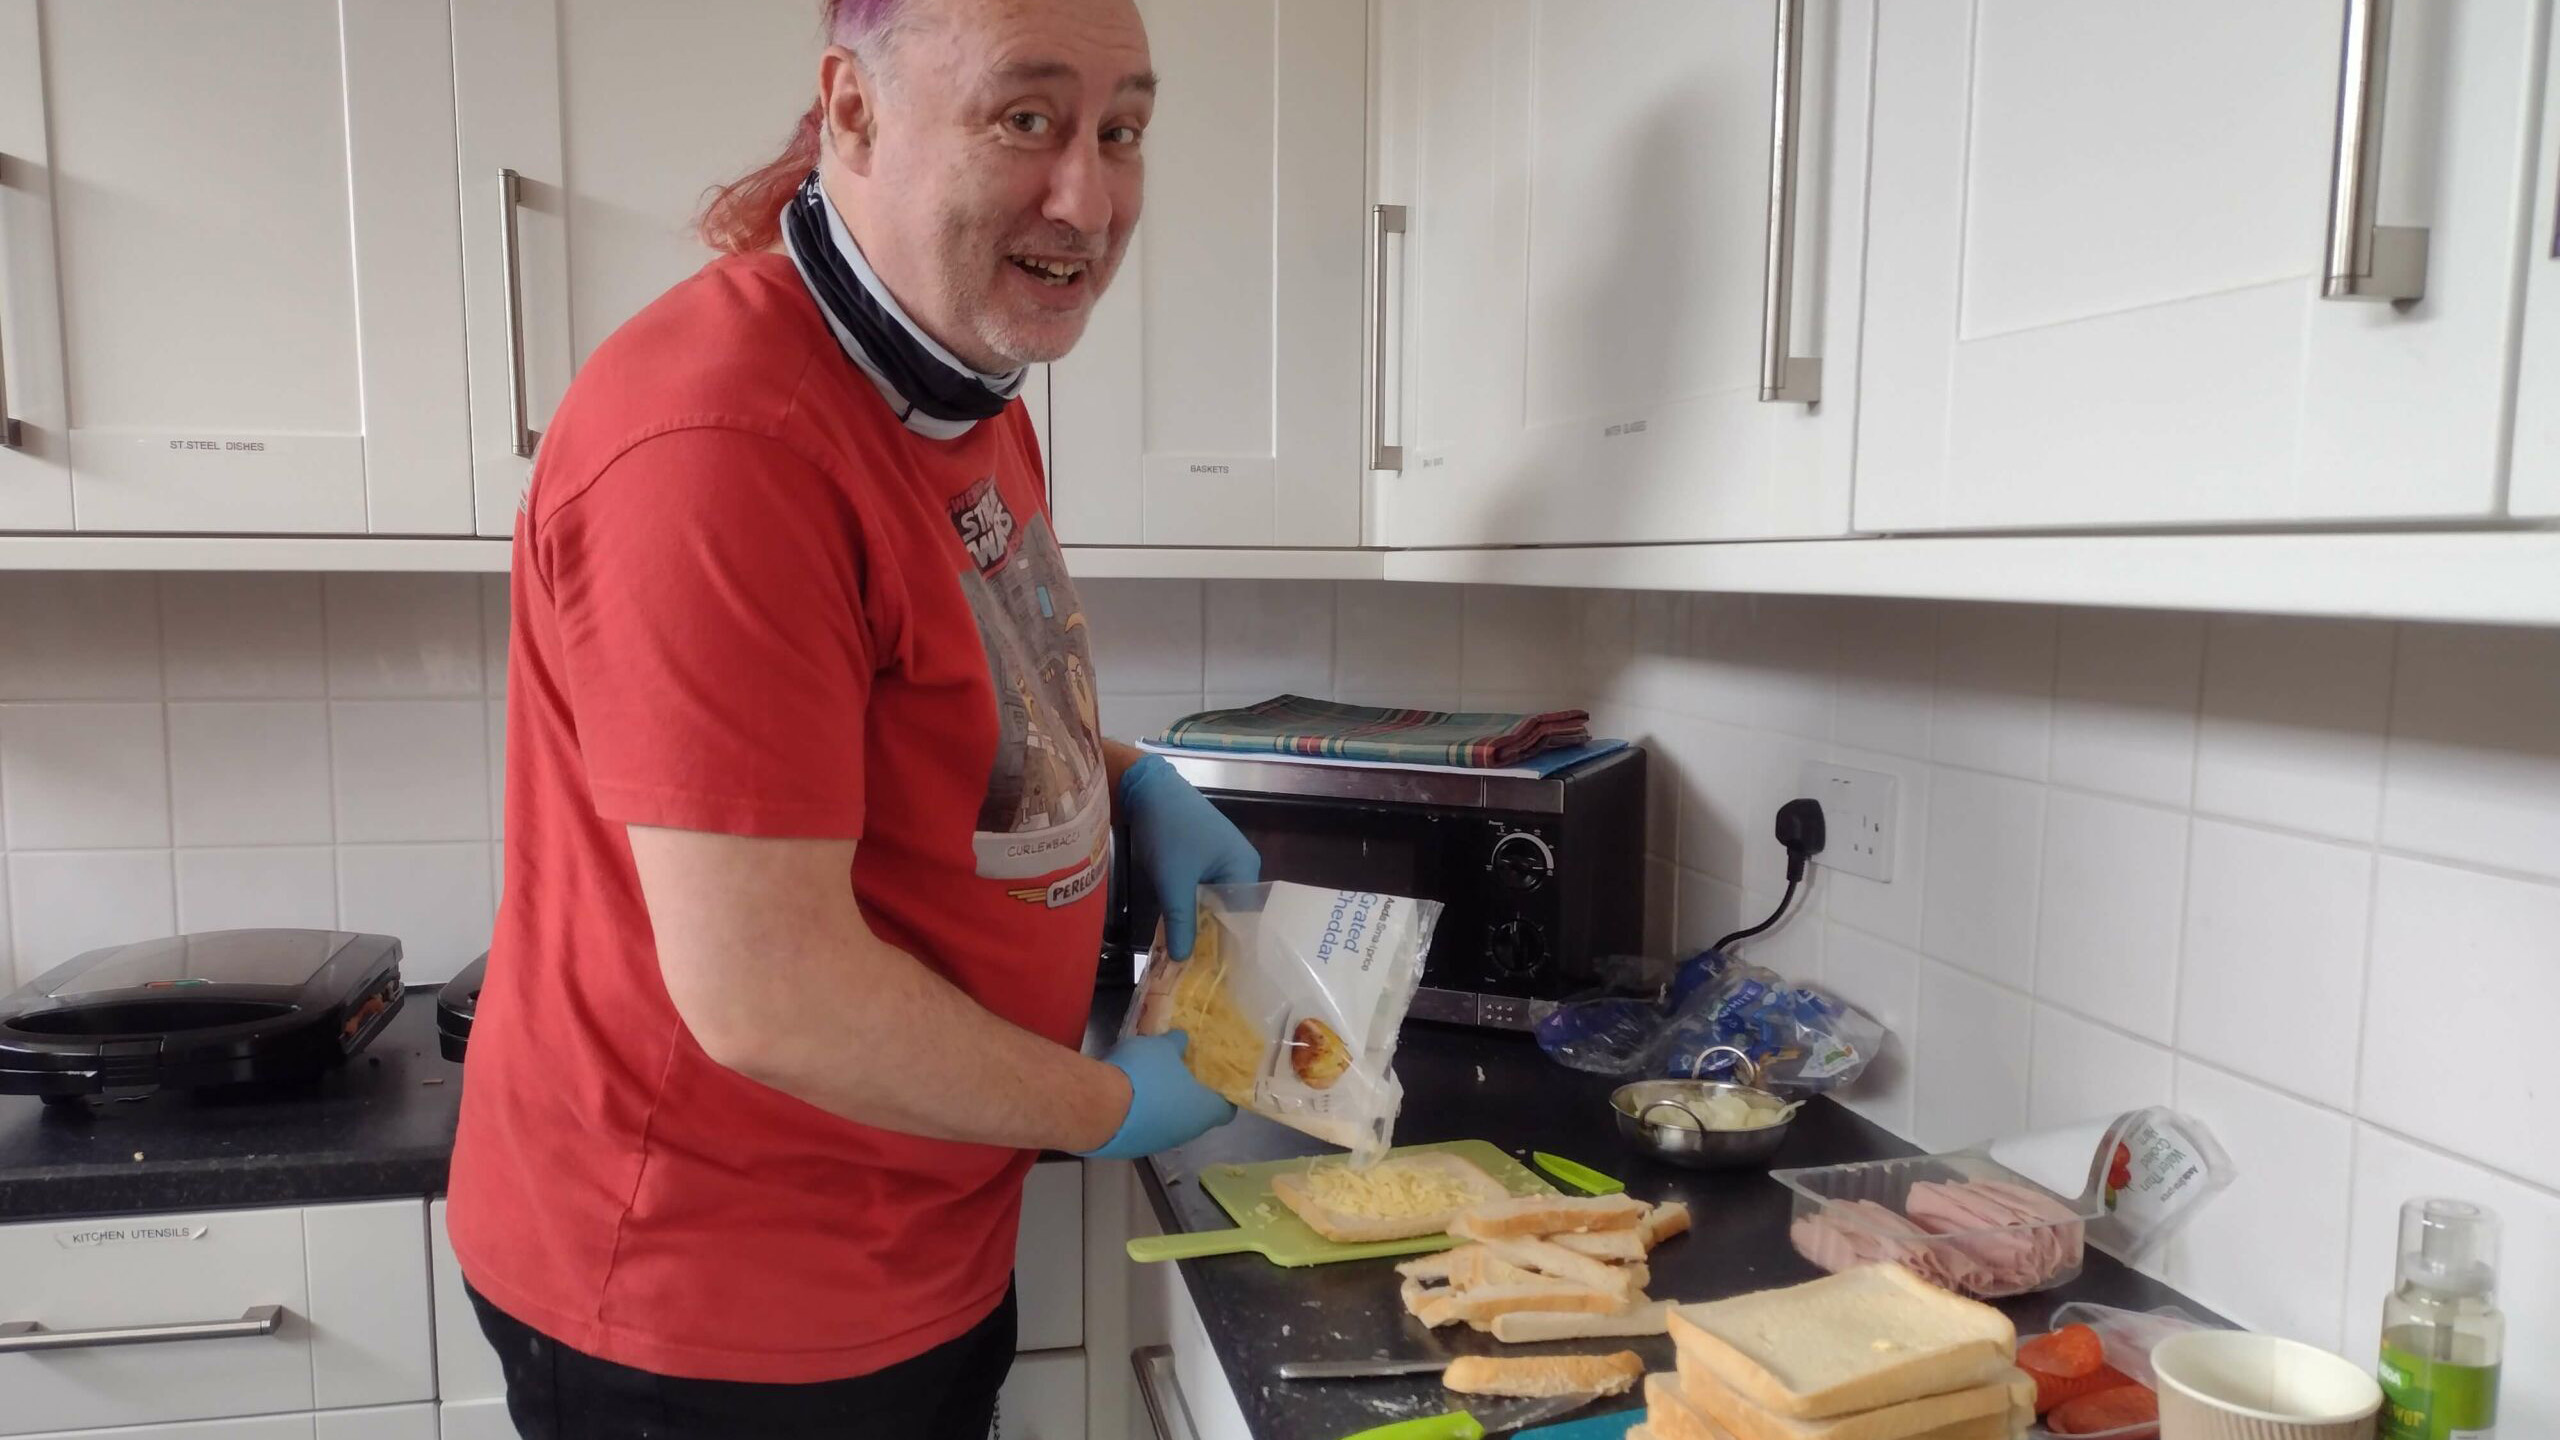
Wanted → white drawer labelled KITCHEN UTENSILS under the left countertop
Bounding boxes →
[0,1199,435,1435]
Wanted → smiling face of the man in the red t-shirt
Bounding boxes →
[822,0,1155,372]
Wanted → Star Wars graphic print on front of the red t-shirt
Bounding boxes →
[950,479,1111,907]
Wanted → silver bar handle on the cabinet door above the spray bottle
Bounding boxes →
[2319,0,2427,300]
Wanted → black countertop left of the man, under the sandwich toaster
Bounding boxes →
[0,986,463,1220]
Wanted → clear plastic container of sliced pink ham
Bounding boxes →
[1769,1150,2107,1299]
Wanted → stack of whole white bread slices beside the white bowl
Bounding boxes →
[1636,1266,2035,1440]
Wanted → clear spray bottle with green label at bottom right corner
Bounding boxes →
[2381,1199,2506,1440]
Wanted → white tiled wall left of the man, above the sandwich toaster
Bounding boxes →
[0,574,507,984]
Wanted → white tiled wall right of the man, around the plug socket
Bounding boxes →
[1085,582,2560,1435]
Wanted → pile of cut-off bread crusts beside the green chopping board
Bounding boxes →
[1395,1194,1690,1343]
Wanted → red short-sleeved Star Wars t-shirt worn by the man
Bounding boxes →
[451,254,1108,1381]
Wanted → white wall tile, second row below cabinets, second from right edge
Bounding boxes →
[2179,820,2373,1109]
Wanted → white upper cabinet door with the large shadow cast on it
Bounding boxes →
[1377,0,1874,546]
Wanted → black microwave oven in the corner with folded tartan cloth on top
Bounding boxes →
[1103,746,1644,1030]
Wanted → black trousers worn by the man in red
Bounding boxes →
[471,1276,1014,1440]
